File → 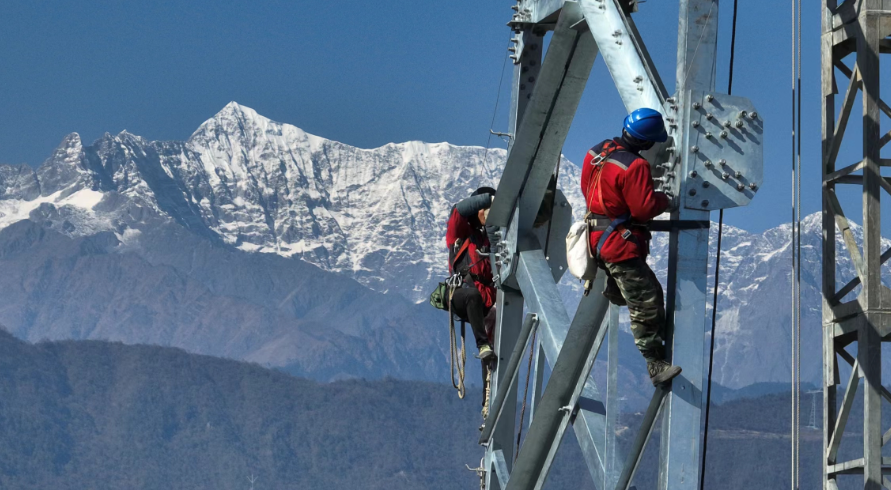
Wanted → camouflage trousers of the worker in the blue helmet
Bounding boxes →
[603,258,665,361]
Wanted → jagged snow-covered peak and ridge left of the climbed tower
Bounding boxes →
[0,102,582,301]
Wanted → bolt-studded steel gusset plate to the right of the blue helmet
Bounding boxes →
[681,91,764,211]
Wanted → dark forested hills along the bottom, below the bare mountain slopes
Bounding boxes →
[0,332,840,490]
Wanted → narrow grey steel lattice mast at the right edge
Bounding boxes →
[821,0,891,489]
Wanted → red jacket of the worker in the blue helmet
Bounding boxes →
[582,138,669,263]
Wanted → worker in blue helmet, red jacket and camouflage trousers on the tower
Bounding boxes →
[582,108,681,386]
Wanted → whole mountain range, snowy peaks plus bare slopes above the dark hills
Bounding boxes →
[0,102,887,387]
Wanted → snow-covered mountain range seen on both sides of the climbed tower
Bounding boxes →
[0,102,872,387]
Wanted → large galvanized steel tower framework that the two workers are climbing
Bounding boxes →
[480,0,763,490]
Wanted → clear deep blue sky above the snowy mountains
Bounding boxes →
[0,0,852,231]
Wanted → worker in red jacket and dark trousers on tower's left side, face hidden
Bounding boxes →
[446,187,495,362]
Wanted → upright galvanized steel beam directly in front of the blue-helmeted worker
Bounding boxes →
[658,0,718,490]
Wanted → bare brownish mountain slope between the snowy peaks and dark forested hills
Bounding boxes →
[0,220,448,381]
